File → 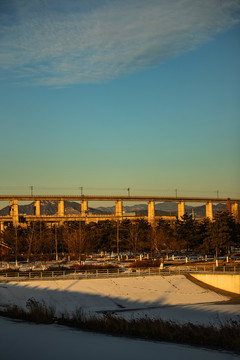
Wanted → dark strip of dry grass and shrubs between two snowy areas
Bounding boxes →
[0,298,240,354]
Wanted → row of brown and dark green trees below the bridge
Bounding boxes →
[0,211,240,263]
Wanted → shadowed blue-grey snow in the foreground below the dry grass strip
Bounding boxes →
[0,317,239,360]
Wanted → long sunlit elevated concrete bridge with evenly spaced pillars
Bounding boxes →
[0,195,240,230]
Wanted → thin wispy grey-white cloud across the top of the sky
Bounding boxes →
[0,0,240,86]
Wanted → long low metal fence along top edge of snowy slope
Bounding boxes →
[0,266,240,282]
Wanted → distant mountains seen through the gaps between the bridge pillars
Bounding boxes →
[0,200,226,217]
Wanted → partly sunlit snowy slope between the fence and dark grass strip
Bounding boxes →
[0,275,240,325]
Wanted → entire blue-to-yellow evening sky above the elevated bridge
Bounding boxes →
[0,0,240,198]
